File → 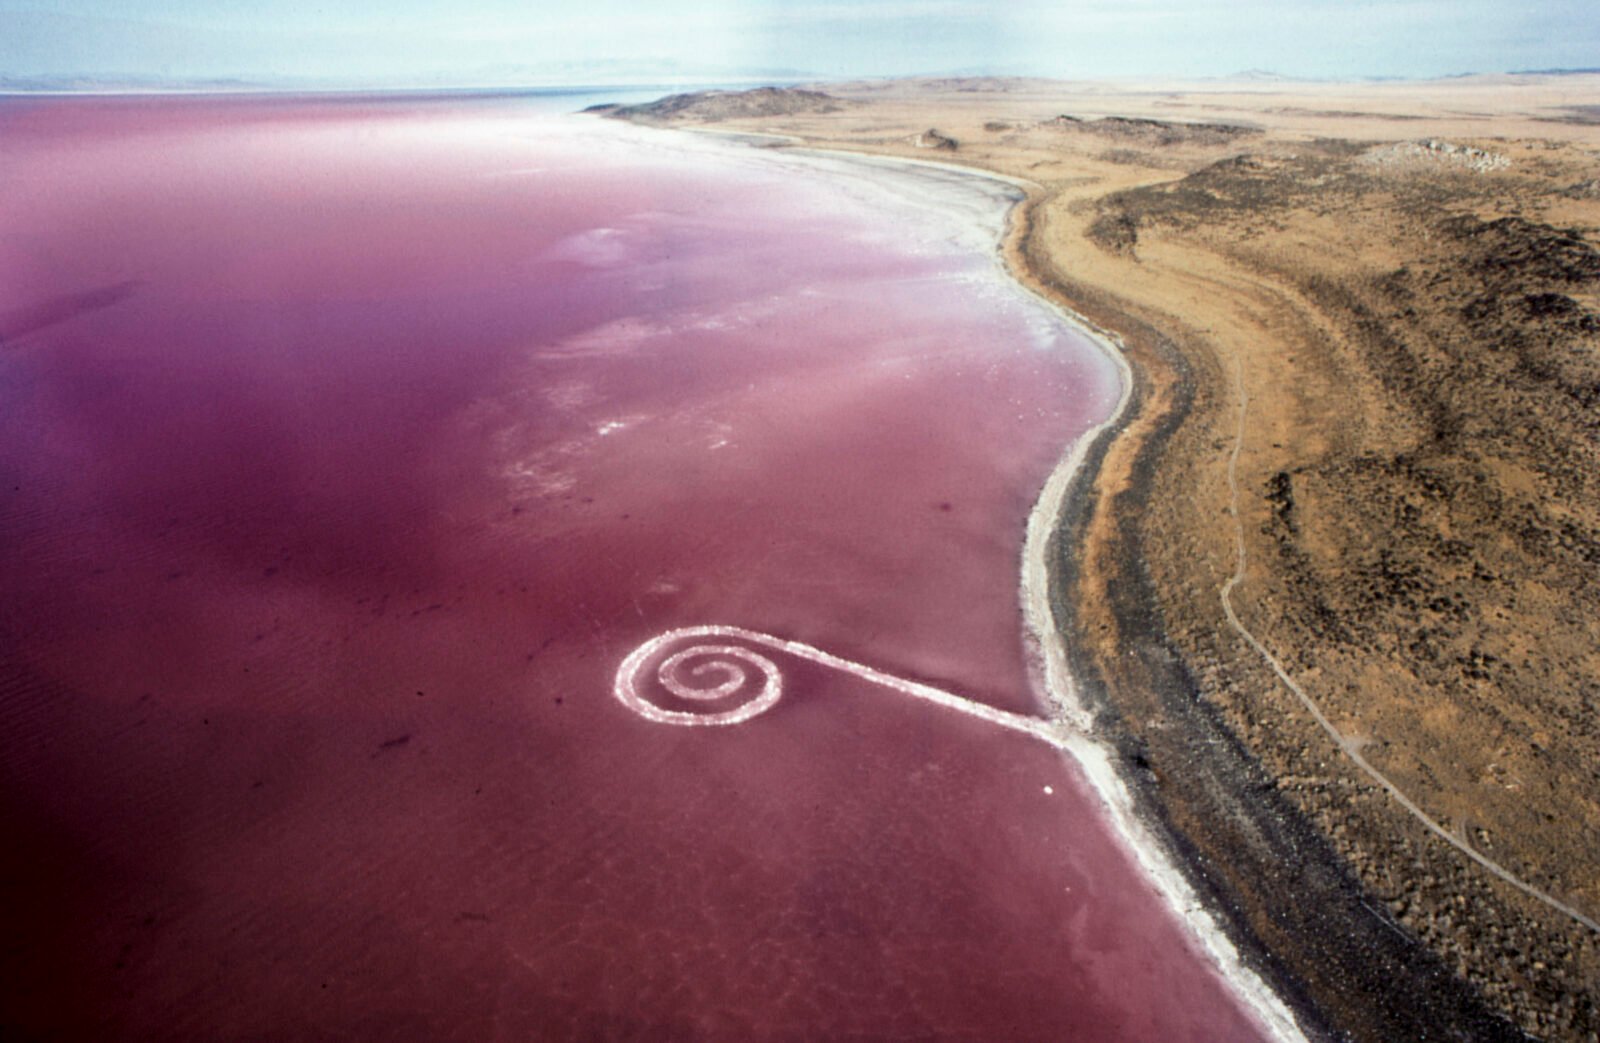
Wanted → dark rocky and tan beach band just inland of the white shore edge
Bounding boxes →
[1008,199,1525,1040]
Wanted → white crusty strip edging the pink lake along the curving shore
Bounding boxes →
[624,131,1306,1040]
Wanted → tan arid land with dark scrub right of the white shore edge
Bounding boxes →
[608,75,1600,1040]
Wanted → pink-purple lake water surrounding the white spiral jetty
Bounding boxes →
[0,99,1259,1041]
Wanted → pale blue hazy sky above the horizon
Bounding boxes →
[0,0,1600,82]
